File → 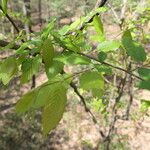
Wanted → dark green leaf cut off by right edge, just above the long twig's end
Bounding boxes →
[138,68,150,80]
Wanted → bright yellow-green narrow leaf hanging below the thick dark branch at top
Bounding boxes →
[93,15,105,42]
